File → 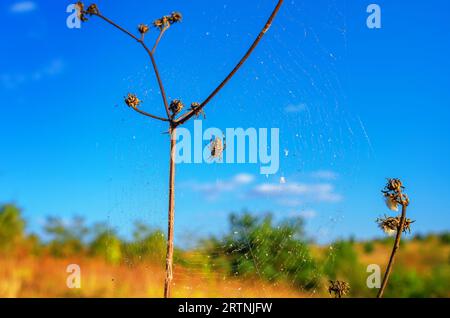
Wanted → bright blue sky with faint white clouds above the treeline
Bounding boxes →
[0,0,450,242]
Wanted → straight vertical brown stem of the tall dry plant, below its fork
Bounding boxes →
[164,128,177,298]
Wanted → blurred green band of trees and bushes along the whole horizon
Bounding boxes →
[0,204,450,297]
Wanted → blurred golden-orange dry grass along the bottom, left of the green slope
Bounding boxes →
[0,257,306,298]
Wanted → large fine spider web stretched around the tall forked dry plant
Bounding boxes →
[102,0,372,297]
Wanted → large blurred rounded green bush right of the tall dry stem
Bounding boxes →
[207,213,318,289]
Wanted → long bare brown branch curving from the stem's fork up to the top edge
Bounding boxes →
[175,0,283,126]
